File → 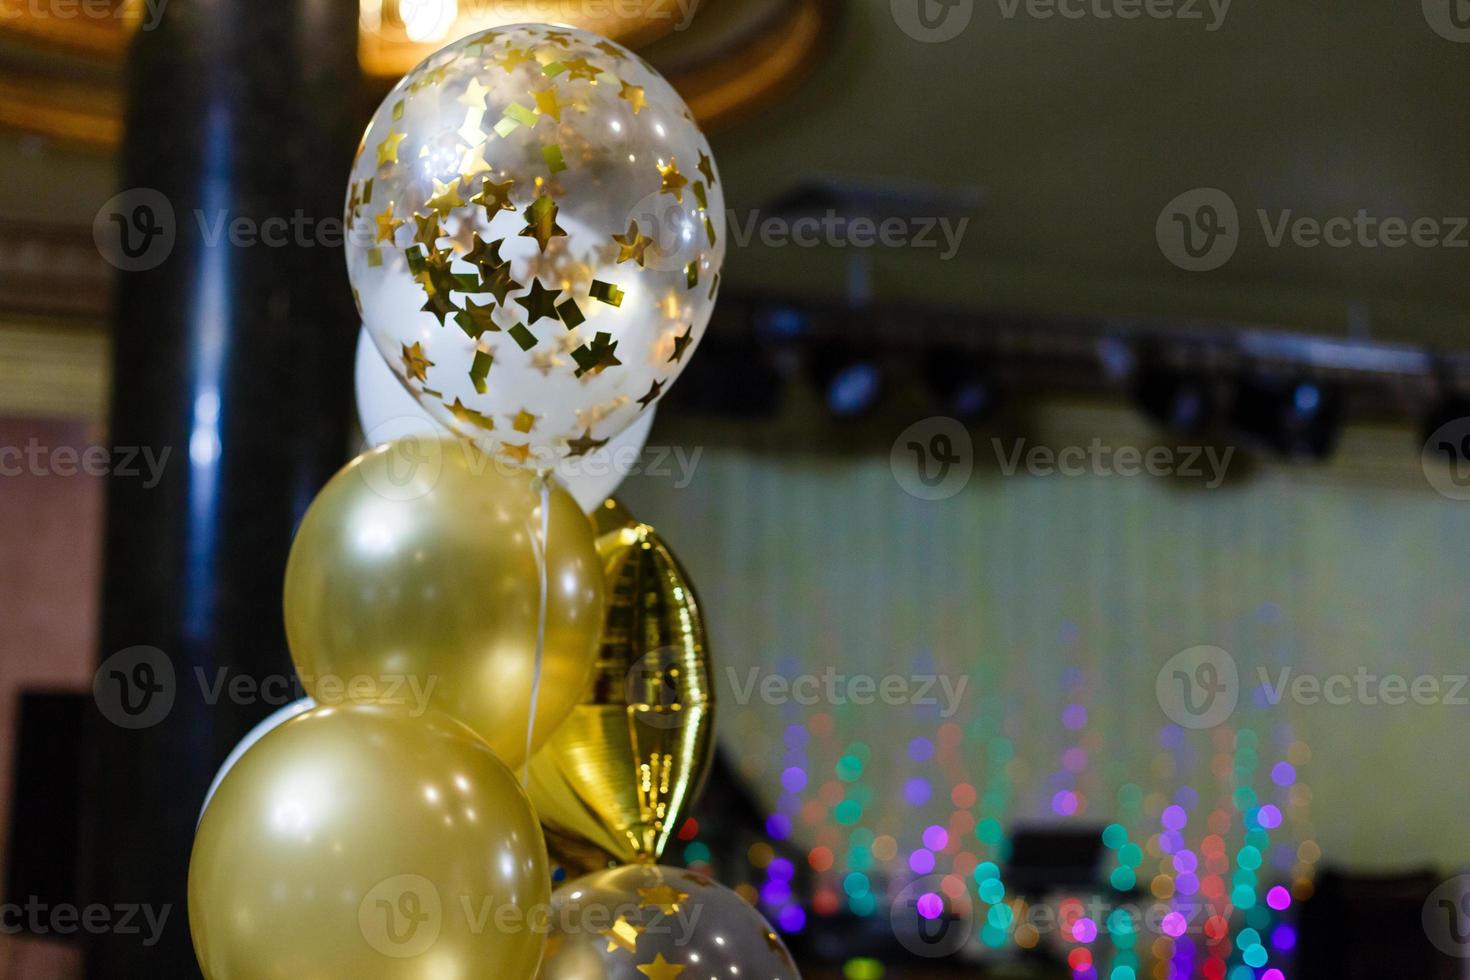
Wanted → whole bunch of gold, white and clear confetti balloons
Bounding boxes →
[190,25,798,980]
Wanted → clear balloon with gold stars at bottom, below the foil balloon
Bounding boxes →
[539,864,801,980]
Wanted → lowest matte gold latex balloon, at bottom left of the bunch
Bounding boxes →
[188,705,550,980]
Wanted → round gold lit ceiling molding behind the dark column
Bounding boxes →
[0,0,839,153]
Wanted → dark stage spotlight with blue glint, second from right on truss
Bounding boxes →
[1230,375,1342,460]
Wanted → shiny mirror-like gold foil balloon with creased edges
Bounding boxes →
[528,508,714,871]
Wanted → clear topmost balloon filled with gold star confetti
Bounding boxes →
[347,24,726,470]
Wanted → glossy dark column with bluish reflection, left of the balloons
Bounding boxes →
[84,0,366,980]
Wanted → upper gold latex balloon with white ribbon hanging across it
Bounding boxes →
[285,436,603,765]
